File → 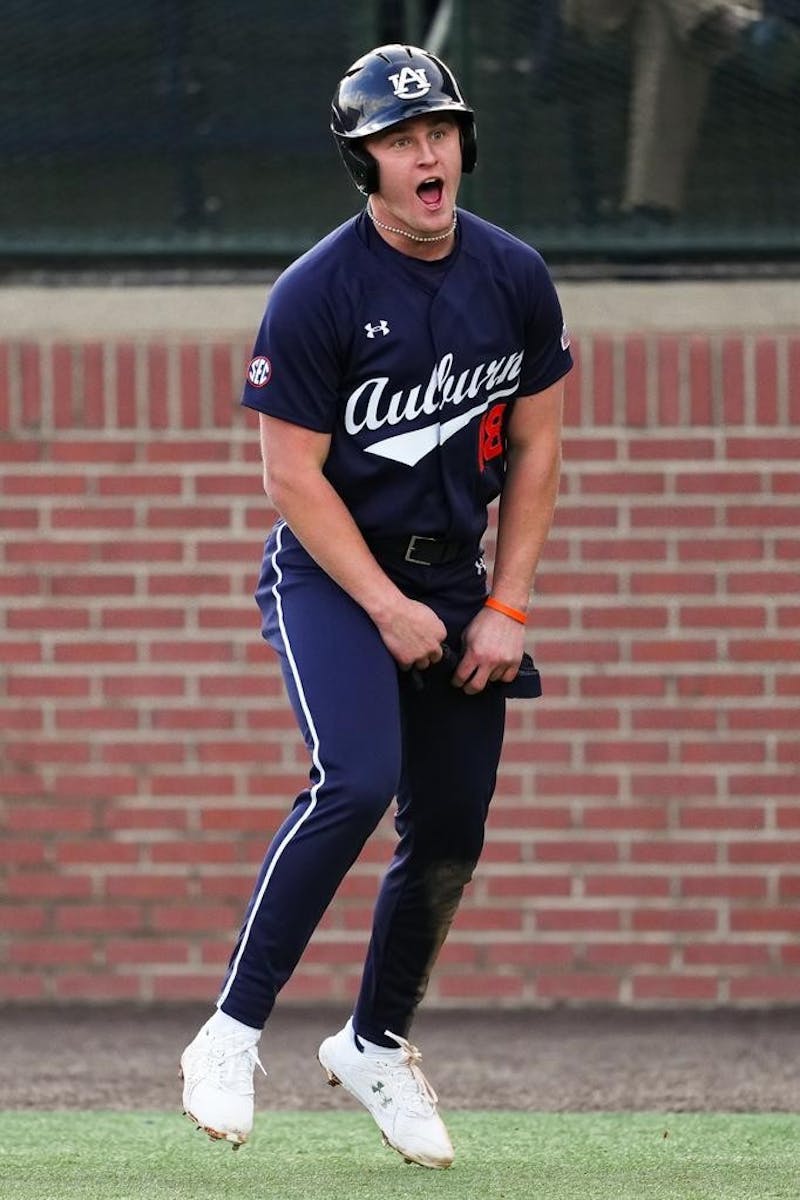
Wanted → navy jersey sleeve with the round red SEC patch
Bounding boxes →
[241,267,341,433]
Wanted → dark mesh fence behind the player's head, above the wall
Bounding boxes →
[0,0,800,264]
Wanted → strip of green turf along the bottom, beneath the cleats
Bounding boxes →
[0,1112,800,1200]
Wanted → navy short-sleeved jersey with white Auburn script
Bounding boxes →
[242,210,572,541]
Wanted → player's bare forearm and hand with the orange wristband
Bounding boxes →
[453,379,564,692]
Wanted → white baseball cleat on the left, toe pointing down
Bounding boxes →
[180,1025,266,1150]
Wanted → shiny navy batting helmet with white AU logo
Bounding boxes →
[331,46,477,196]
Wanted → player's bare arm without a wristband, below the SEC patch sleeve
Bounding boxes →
[259,414,446,668]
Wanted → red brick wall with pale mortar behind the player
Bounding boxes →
[0,332,800,1006]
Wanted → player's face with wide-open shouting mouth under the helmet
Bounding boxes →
[366,113,462,252]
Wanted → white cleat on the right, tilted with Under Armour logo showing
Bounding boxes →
[318,1021,453,1168]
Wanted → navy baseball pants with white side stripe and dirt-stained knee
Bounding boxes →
[218,522,505,1045]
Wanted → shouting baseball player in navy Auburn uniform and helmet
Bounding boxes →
[181,46,571,1168]
